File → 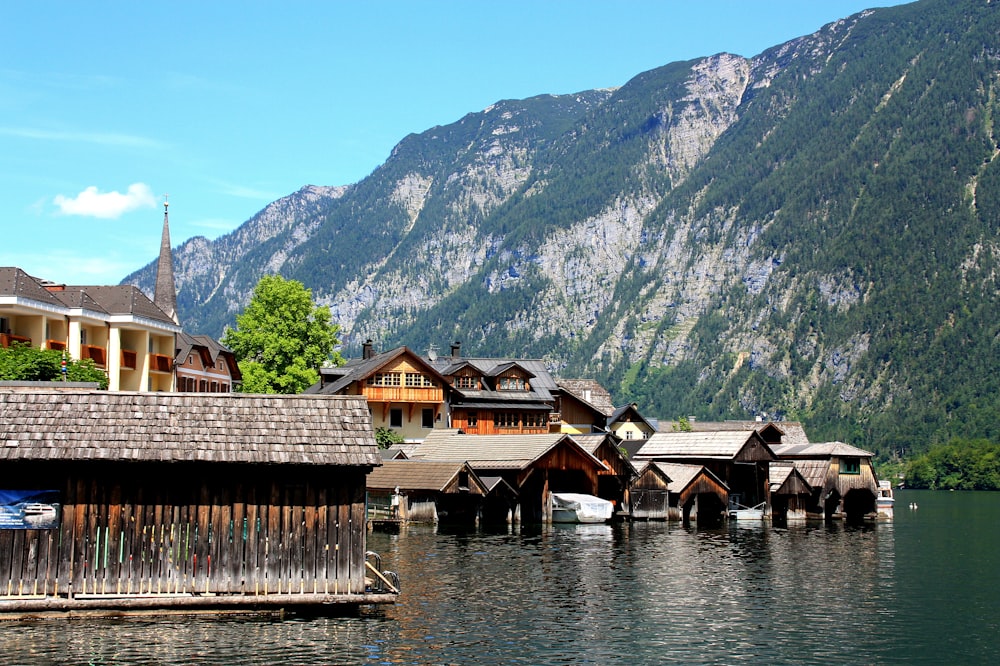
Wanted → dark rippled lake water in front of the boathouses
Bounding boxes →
[0,491,1000,664]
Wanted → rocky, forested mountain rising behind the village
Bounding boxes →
[126,0,1000,456]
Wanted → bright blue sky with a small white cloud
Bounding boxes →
[0,0,912,284]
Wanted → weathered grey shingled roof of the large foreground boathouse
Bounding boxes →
[0,389,381,466]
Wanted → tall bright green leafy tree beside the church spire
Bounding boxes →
[222,275,344,393]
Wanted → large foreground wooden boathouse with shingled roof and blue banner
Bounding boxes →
[0,389,398,614]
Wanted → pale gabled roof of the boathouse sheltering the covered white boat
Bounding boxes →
[411,433,604,470]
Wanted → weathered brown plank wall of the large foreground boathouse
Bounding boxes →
[0,464,366,597]
